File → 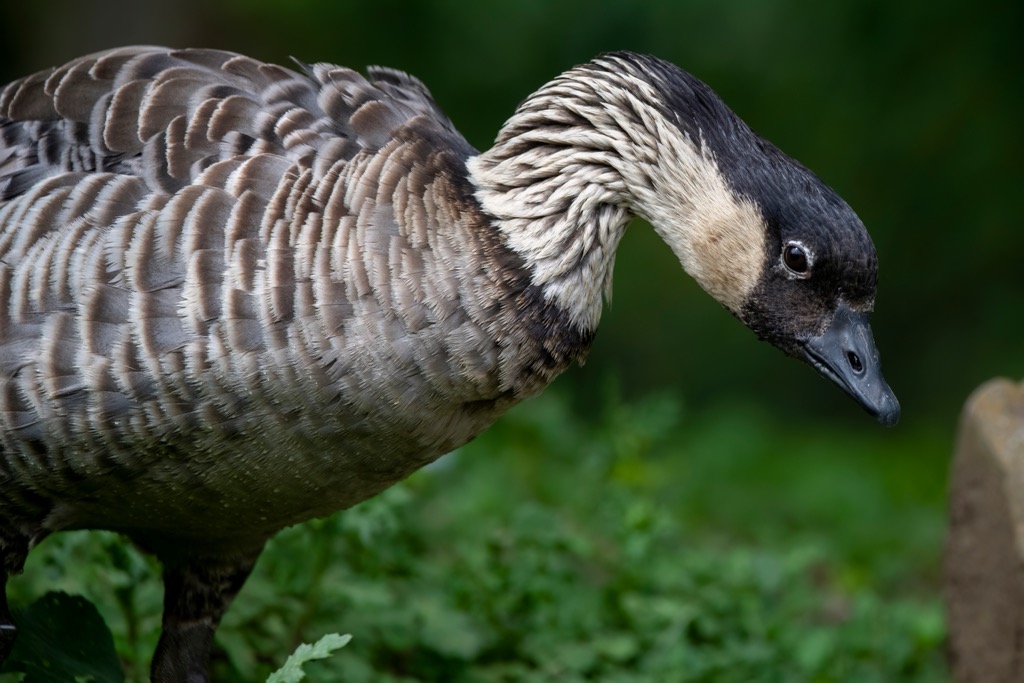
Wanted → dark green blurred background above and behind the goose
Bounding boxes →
[0,0,1024,433]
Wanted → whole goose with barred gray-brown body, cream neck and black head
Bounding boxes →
[0,47,899,681]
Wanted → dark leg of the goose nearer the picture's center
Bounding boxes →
[153,550,259,683]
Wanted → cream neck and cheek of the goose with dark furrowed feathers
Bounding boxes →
[468,63,765,330]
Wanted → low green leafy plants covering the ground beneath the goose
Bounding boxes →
[0,392,948,683]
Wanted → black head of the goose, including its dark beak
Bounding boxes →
[723,139,900,425]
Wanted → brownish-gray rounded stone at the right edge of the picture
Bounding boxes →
[944,379,1024,683]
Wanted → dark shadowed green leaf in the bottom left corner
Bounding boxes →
[4,592,124,683]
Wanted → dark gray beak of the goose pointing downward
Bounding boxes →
[804,303,899,427]
